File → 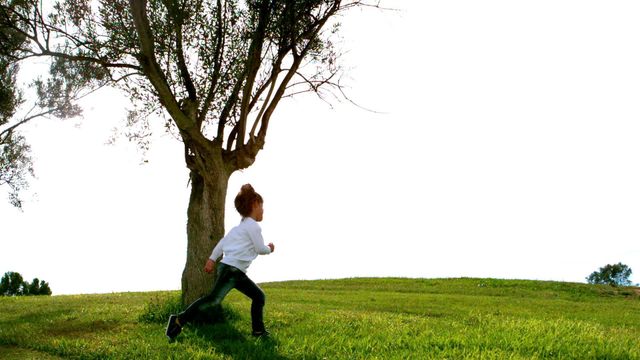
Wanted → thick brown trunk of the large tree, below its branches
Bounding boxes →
[182,170,230,305]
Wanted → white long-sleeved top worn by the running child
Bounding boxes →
[209,217,271,272]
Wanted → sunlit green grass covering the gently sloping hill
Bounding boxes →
[0,278,640,360]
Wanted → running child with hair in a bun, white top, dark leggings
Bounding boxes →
[166,184,275,341]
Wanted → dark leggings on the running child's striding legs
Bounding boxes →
[178,263,265,332]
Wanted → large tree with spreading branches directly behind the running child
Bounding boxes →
[0,0,377,303]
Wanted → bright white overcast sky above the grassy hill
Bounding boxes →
[0,0,640,294]
